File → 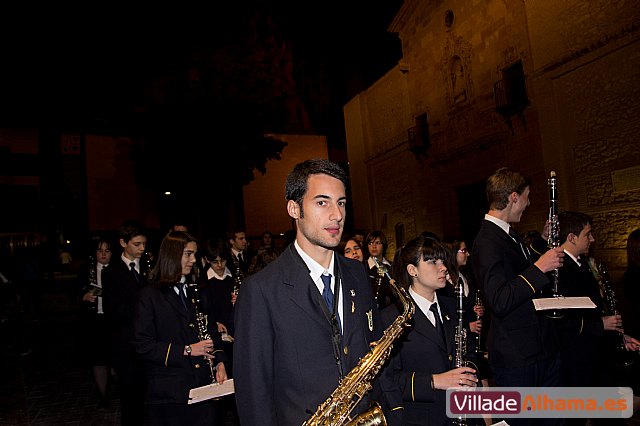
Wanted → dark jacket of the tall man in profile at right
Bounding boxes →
[472,220,558,368]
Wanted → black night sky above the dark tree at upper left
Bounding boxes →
[0,0,402,143]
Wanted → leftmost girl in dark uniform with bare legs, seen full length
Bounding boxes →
[77,238,111,408]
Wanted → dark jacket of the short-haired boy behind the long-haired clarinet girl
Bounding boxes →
[102,257,147,352]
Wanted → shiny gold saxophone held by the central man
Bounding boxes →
[303,256,415,426]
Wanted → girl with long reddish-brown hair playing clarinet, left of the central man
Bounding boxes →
[133,231,227,426]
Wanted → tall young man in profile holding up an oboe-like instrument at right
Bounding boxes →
[471,167,564,424]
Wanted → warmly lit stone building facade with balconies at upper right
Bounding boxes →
[344,0,640,278]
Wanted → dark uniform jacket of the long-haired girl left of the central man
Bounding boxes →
[133,285,226,404]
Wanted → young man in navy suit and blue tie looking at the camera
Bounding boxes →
[233,160,376,426]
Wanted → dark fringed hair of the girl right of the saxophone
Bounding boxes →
[392,236,448,289]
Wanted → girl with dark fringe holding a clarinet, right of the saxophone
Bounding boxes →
[380,236,484,425]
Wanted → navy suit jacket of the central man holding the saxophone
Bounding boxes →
[233,244,377,426]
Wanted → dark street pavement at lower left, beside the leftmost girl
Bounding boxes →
[0,280,120,426]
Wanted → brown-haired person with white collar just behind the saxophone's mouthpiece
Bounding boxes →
[365,230,396,309]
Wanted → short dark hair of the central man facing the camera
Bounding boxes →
[284,158,348,217]
